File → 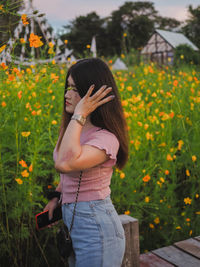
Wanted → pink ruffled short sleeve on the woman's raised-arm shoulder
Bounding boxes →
[84,129,119,167]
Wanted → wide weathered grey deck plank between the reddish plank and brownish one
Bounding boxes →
[152,246,200,267]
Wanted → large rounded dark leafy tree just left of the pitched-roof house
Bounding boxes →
[108,2,157,54]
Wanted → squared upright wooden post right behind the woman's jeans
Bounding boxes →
[119,215,140,267]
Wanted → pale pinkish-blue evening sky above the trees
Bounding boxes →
[32,0,200,31]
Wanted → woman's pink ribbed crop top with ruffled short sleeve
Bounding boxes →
[53,127,119,203]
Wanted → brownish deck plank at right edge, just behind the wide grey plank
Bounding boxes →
[174,238,200,259]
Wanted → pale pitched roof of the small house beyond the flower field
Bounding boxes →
[156,29,199,51]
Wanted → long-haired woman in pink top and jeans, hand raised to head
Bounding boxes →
[45,58,128,267]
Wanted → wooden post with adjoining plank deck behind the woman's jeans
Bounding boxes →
[119,215,200,267]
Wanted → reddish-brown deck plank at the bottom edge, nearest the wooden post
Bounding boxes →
[140,252,174,267]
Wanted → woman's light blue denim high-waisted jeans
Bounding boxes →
[62,197,125,267]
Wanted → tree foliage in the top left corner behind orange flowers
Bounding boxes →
[0,0,23,45]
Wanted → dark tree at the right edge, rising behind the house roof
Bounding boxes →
[182,5,200,48]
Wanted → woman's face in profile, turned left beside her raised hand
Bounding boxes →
[65,75,81,114]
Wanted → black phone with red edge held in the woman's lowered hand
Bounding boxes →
[35,206,62,230]
